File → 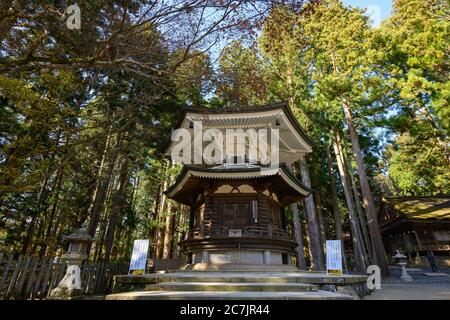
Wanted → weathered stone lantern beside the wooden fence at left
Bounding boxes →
[50,224,93,299]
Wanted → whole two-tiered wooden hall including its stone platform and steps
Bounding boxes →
[107,103,367,300]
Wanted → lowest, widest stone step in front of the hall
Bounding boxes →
[106,290,354,300]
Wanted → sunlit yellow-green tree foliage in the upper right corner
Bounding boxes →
[381,0,450,137]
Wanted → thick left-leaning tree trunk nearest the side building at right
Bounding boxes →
[342,101,389,273]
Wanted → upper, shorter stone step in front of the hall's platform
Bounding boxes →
[145,279,318,292]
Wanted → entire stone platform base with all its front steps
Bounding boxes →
[106,270,370,300]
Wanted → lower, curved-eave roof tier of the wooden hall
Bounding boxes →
[164,164,311,204]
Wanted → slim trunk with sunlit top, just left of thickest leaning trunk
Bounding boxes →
[333,135,366,273]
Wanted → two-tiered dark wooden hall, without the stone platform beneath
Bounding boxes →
[165,103,312,270]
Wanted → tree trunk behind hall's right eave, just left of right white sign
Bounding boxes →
[299,157,324,270]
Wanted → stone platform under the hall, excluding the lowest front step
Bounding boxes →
[113,270,371,299]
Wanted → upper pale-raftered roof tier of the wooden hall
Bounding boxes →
[164,102,312,164]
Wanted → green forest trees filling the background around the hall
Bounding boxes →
[0,0,450,259]
